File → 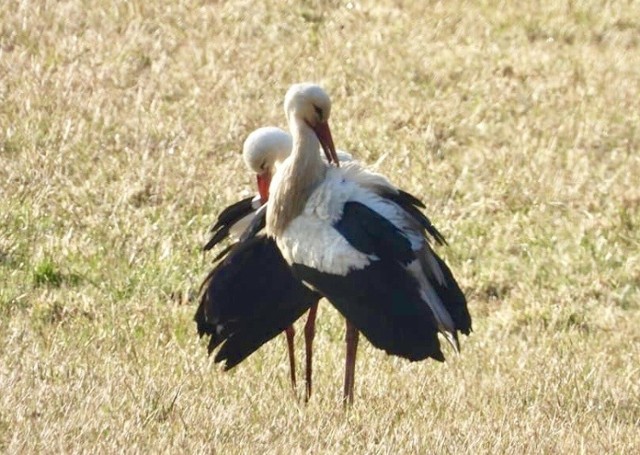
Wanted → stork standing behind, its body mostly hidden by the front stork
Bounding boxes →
[195,127,320,399]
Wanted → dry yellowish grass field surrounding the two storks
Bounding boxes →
[0,0,640,454]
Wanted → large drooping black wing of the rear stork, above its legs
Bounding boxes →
[194,236,320,370]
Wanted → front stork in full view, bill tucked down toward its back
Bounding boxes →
[258,84,471,403]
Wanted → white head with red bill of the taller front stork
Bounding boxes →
[284,82,340,165]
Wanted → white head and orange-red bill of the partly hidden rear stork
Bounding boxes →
[242,126,291,204]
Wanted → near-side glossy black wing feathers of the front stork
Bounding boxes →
[292,201,444,361]
